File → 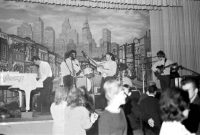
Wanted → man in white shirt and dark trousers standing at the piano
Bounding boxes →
[31,56,53,112]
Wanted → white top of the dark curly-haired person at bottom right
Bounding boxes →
[160,121,195,135]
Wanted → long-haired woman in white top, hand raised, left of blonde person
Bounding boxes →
[65,87,98,135]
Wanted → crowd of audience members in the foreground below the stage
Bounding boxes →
[50,78,200,135]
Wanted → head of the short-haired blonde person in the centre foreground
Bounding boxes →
[103,79,128,106]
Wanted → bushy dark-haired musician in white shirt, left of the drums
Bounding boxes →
[60,50,81,89]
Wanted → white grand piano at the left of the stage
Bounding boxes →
[0,72,43,111]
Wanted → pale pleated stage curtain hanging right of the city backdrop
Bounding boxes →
[150,0,200,75]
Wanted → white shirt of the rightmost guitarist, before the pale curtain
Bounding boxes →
[152,59,173,75]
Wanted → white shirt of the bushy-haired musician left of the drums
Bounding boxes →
[60,58,81,77]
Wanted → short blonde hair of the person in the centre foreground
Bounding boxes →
[103,79,121,101]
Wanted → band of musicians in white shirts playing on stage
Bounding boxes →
[1,50,195,112]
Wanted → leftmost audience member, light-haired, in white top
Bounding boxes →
[50,87,68,135]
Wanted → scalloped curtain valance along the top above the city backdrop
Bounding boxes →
[21,0,183,10]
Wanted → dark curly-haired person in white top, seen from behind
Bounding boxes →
[160,88,193,135]
